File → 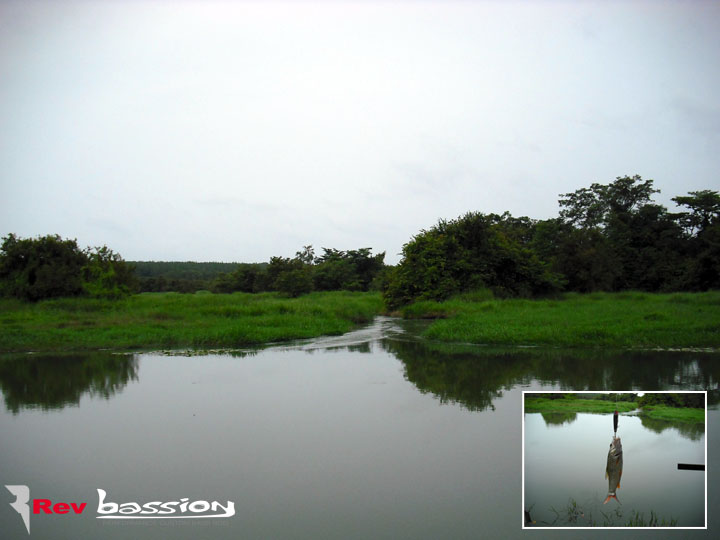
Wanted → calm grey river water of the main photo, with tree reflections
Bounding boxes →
[0,318,720,539]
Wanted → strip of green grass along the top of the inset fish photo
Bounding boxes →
[525,395,705,424]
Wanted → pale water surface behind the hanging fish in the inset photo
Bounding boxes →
[525,413,705,527]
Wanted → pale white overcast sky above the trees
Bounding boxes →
[0,0,720,263]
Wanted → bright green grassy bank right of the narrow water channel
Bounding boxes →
[401,291,720,348]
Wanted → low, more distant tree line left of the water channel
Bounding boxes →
[0,234,385,301]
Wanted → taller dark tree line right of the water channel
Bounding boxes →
[383,176,720,309]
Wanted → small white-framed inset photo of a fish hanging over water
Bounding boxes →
[523,392,707,528]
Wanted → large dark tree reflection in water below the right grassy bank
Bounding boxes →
[382,339,720,410]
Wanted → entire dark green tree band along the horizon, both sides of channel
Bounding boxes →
[0,176,720,309]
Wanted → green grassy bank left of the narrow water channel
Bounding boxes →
[0,292,382,352]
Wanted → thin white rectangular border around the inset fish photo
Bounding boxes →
[520,390,709,531]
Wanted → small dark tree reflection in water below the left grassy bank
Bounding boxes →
[0,353,138,414]
